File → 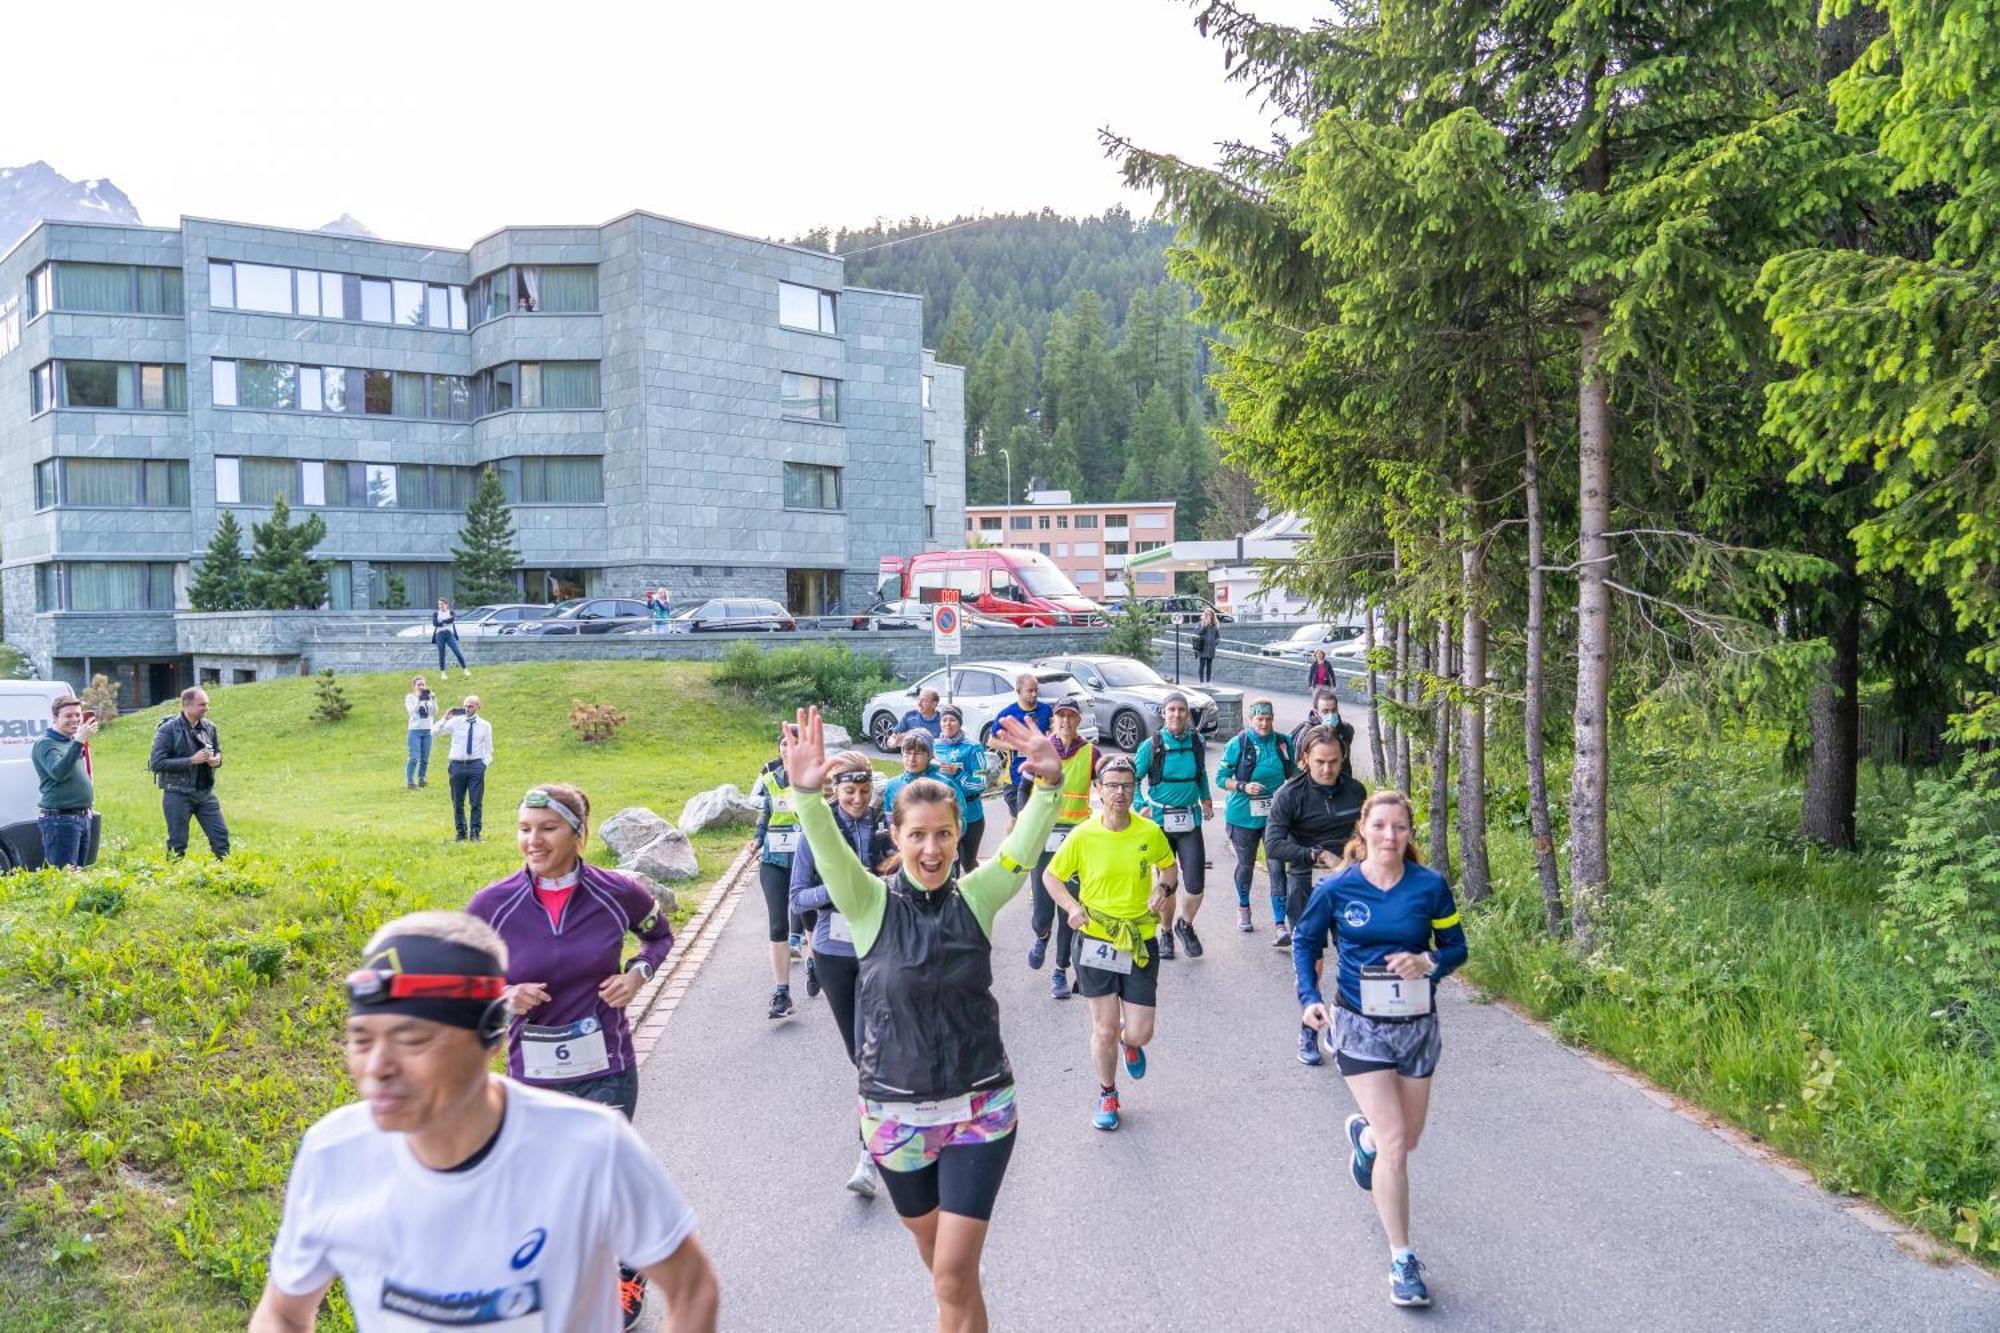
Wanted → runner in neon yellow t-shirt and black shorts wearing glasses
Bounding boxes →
[1042,755,1178,1129]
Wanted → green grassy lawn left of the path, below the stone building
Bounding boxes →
[0,662,796,1333]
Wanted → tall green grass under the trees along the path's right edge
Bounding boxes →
[1468,741,2000,1263]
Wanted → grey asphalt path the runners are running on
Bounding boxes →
[638,701,2000,1333]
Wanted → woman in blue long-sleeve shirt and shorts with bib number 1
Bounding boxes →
[1292,791,1466,1305]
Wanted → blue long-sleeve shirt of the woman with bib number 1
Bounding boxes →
[1292,863,1466,1013]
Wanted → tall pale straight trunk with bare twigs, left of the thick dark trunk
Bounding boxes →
[1570,306,1612,949]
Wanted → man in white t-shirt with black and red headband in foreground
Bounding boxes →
[250,913,718,1333]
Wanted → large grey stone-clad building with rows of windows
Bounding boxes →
[0,212,966,705]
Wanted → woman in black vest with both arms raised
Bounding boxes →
[784,709,1062,1333]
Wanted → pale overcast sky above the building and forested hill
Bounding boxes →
[0,0,1326,246]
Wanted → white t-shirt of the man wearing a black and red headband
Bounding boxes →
[270,1079,694,1333]
